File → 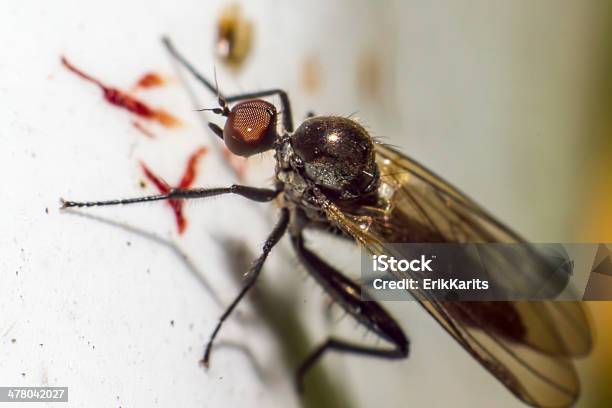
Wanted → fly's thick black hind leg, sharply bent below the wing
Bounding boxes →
[291,233,409,390]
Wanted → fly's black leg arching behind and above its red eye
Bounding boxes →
[162,37,293,132]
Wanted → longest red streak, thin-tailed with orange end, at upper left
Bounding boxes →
[62,56,180,127]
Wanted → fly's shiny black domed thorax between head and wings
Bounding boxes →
[276,116,380,217]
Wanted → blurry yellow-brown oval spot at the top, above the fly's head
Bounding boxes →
[215,3,253,68]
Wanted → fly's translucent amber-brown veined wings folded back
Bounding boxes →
[321,145,592,407]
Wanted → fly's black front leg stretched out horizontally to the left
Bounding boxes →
[61,184,280,208]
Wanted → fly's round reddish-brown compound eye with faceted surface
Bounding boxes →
[223,99,276,156]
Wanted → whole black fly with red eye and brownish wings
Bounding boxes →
[63,38,592,407]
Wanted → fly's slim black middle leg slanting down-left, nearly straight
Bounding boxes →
[201,208,289,367]
